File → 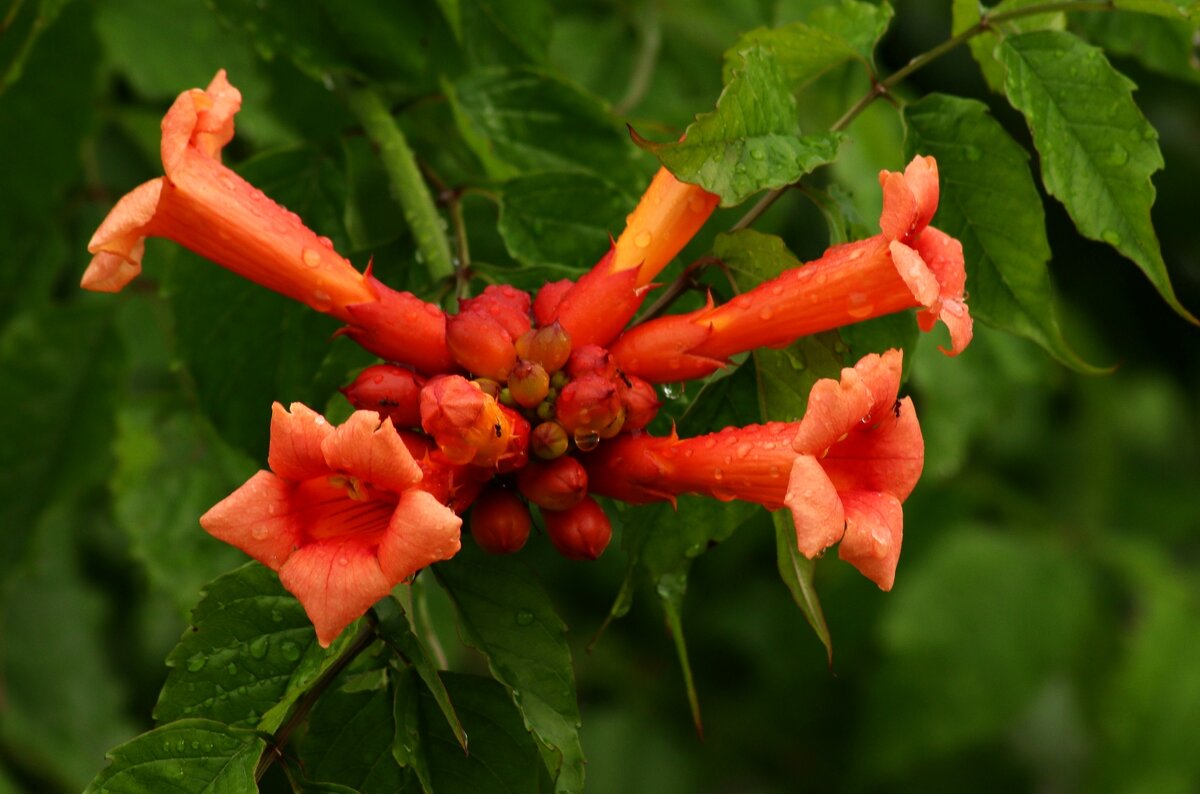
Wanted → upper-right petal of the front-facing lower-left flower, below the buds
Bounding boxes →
[320,410,421,493]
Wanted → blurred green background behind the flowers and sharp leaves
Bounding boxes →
[0,0,1200,794]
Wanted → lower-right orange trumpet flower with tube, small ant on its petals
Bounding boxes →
[584,350,925,590]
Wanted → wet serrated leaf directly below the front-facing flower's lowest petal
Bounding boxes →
[155,563,354,732]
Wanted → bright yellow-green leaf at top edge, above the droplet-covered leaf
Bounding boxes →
[722,0,893,91]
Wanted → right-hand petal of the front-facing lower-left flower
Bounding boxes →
[379,488,462,584]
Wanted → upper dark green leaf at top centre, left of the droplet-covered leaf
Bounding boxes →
[443,67,642,186]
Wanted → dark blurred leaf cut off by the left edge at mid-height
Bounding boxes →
[0,306,121,582]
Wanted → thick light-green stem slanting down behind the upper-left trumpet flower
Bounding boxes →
[344,88,455,279]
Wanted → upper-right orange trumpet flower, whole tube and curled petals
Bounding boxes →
[612,157,972,383]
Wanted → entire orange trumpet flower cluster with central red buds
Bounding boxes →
[83,72,971,644]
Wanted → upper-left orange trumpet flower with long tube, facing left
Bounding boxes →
[82,70,454,373]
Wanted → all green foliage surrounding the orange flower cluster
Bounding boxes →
[0,0,1200,794]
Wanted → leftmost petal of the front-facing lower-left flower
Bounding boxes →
[200,471,300,571]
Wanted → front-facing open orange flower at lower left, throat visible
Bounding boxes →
[200,403,462,646]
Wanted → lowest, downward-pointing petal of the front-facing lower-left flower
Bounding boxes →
[280,537,391,648]
